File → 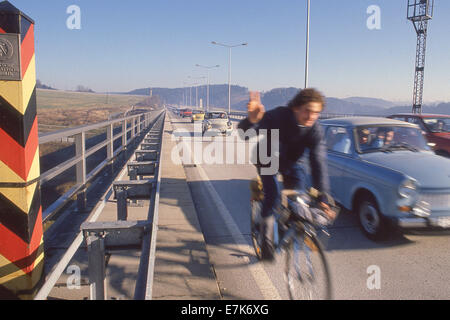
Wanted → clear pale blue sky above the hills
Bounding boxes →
[11,0,450,101]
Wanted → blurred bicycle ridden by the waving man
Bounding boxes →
[250,177,339,300]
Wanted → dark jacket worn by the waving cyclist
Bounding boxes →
[238,107,329,193]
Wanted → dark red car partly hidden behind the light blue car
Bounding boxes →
[388,113,450,158]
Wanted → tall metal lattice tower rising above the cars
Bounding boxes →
[407,0,434,113]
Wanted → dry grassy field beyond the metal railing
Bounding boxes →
[36,89,147,202]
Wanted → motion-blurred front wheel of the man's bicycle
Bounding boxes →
[284,233,331,300]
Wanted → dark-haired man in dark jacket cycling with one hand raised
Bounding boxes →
[238,88,335,261]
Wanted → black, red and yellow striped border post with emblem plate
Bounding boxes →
[0,1,44,299]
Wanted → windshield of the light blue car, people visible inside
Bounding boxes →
[356,125,430,153]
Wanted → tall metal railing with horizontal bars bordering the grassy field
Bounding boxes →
[39,112,161,222]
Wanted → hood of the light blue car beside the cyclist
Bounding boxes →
[361,151,450,189]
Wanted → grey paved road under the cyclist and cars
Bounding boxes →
[171,115,450,299]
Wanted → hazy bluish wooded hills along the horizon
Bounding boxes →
[122,84,450,116]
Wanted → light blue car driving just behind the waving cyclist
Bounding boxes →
[303,117,450,240]
